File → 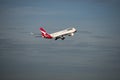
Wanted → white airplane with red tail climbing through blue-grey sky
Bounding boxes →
[31,27,77,40]
